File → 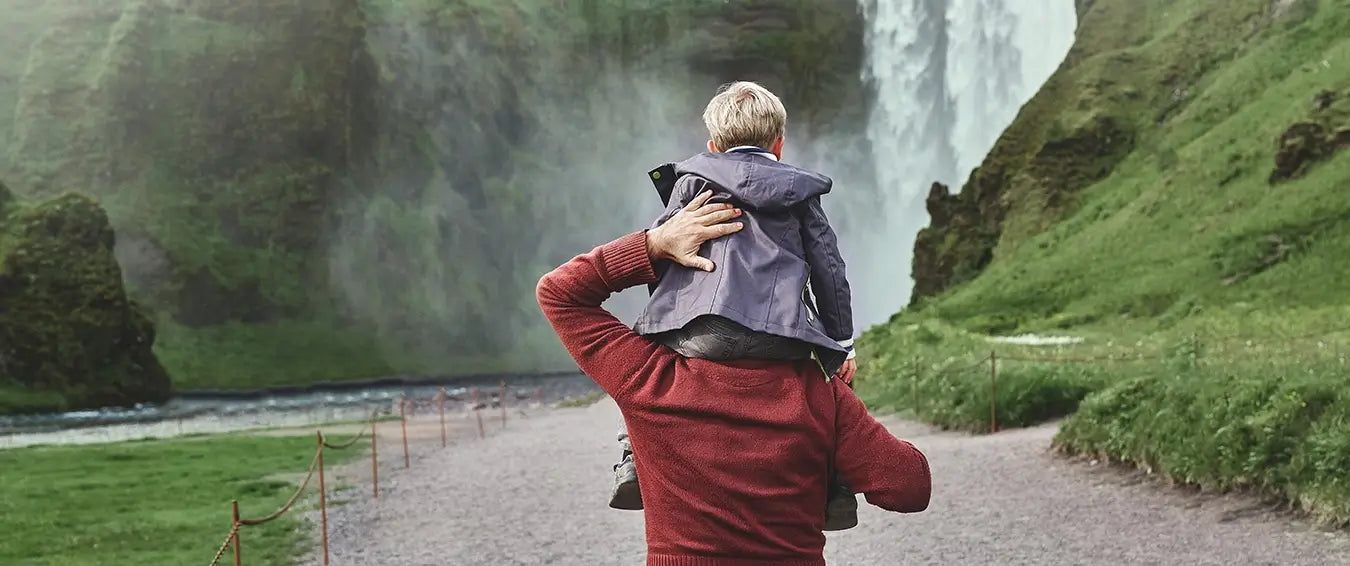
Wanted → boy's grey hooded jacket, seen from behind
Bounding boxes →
[633,153,853,374]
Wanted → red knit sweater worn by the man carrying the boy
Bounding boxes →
[536,232,932,566]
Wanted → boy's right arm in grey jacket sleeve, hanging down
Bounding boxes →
[802,197,853,358]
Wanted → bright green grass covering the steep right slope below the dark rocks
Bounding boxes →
[927,0,1350,332]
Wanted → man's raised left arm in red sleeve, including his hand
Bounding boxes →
[535,193,741,400]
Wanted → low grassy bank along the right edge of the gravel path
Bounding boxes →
[859,309,1350,525]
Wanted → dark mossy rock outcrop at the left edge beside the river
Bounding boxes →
[0,185,170,411]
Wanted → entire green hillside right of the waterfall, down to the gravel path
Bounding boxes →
[861,0,1350,521]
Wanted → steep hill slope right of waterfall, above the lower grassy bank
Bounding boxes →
[914,0,1350,332]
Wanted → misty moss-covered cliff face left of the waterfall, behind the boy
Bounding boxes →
[0,0,865,399]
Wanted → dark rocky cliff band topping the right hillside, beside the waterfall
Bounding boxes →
[911,0,1280,304]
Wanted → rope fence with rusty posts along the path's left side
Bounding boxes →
[203,380,543,566]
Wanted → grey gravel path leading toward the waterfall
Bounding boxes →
[311,401,1350,566]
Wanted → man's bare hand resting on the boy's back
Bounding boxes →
[647,190,744,272]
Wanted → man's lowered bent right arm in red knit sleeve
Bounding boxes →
[834,382,933,513]
